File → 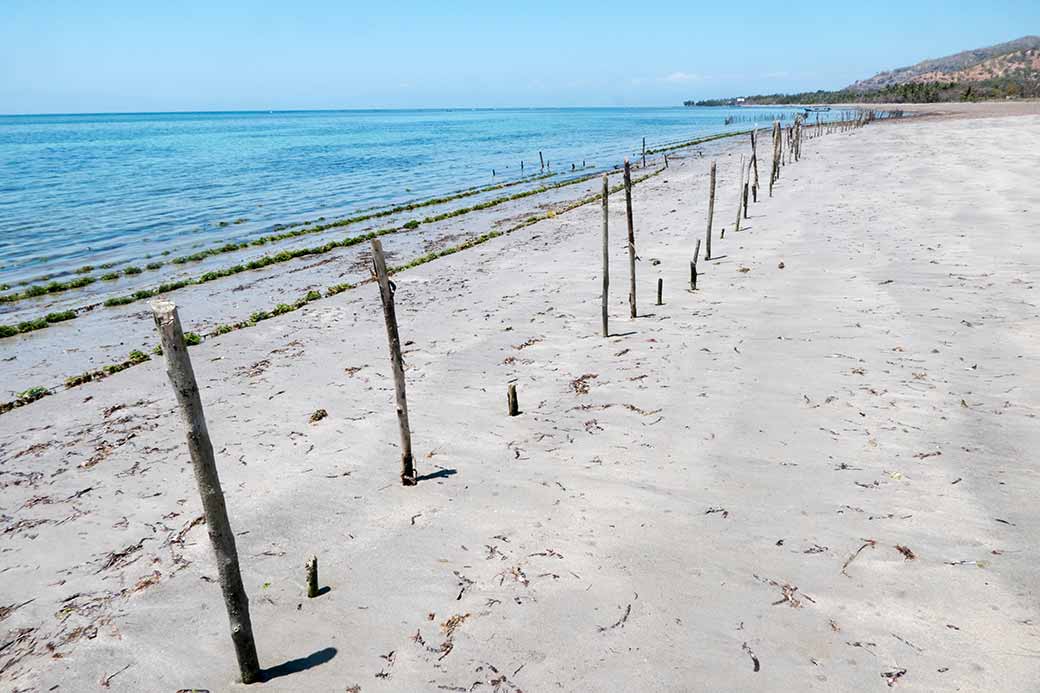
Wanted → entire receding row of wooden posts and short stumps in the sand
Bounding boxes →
[152,109,874,684]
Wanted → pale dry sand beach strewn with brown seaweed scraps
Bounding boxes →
[0,105,1040,693]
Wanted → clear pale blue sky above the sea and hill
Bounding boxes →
[0,0,1040,113]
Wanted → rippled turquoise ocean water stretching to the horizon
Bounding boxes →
[0,107,837,288]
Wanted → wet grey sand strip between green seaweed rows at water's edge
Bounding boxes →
[0,130,777,401]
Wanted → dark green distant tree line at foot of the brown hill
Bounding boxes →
[682,74,1040,106]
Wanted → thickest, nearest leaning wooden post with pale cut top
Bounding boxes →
[152,301,260,684]
